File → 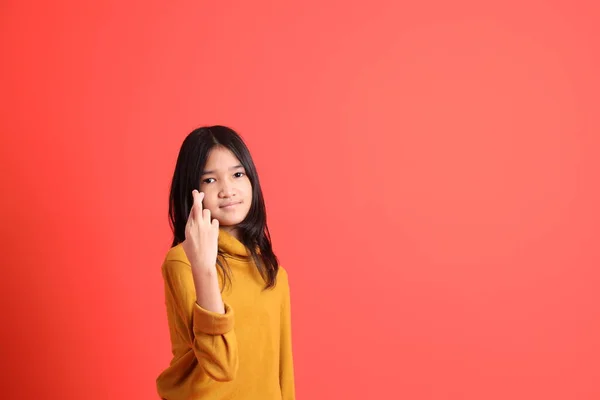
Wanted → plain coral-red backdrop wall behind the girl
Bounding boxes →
[0,0,600,400]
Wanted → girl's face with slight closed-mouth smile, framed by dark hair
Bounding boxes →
[200,146,252,235]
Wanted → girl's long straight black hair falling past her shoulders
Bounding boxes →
[169,125,279,289]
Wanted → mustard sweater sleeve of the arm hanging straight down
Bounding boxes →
[279,267,296,400]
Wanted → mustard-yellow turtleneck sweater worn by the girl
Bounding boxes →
[156,230,295,400]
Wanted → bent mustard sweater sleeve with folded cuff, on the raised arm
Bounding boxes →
[162,260,238,382]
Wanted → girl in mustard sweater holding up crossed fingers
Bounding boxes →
[156,126,295,400]
